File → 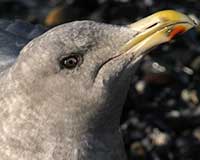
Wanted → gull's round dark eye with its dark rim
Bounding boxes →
[60,55,81,69]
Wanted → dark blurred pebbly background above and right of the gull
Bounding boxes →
[0,0,200,160]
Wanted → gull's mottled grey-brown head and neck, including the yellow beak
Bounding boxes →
[0,10,197,160]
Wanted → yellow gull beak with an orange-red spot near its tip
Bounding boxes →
[121,10,199,58]
